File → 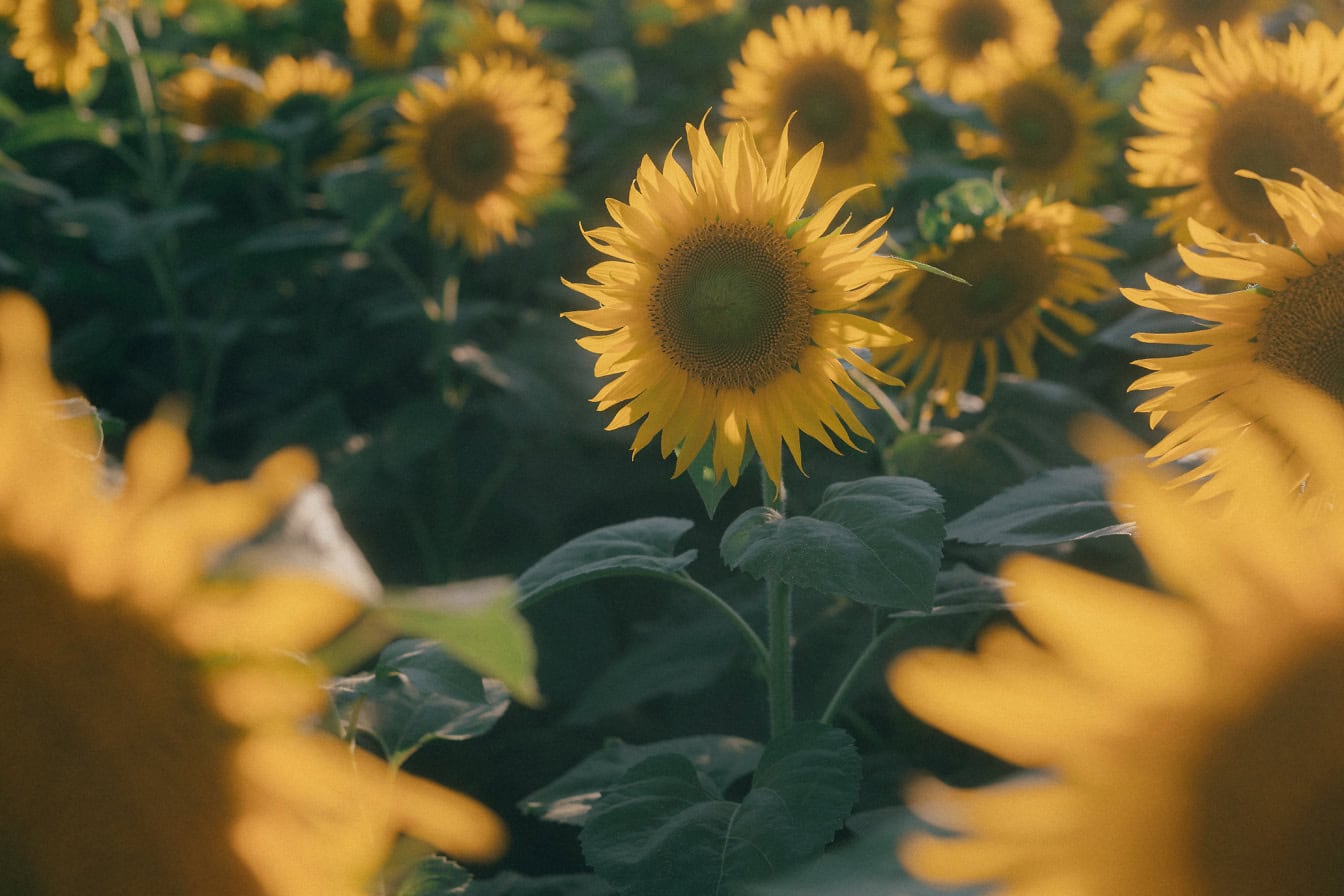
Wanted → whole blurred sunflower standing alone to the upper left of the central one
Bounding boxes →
[386,56,567,257]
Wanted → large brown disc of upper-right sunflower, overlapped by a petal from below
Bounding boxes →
[1208,91,1344,242]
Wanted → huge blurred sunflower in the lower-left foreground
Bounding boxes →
[0,292,504,896]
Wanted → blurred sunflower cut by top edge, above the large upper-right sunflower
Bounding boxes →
[1086,0,1282,66]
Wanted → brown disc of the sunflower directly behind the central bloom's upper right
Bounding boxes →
[780,58,872,164]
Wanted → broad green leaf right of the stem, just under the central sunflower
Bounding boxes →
[719,476,943,610]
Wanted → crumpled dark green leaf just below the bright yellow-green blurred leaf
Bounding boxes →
[327,638,509,766]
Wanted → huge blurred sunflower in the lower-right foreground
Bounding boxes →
[888,370,1344,896]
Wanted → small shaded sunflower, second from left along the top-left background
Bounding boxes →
[163,44,278,168]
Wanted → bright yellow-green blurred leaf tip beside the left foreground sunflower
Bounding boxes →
[375,578,540,705]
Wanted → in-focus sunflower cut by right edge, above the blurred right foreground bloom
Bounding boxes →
[1121,172,1344,494]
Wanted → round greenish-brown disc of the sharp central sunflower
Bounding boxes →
[649,222,812,388]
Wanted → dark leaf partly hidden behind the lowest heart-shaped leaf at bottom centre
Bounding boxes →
[517,735,762,825]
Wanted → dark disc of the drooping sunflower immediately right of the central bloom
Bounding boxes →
[910,227,1055,340]
